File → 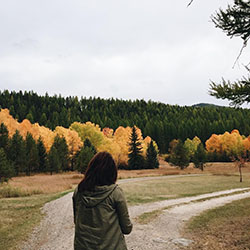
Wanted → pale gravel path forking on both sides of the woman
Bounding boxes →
[20,179,250,250]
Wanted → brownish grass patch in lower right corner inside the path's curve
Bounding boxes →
[185,198,250,250]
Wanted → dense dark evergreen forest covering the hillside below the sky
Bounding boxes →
[0,90,250,153]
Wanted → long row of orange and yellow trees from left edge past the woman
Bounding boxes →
[0,109,153,164]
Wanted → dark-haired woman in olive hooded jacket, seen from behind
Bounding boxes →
[73,152,132,250]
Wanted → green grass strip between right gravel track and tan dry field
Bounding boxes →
[120,174,250,205]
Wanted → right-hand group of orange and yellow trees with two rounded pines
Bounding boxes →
[165,129,250,170]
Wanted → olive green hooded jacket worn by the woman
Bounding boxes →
[73,184,132,250]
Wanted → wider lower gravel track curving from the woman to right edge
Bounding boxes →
[126,190,250,250]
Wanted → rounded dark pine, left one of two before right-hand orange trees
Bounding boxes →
[169,140,189,169]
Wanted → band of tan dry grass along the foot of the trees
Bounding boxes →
[0,160,250,198]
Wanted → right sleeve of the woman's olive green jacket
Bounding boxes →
[115,186,133,234]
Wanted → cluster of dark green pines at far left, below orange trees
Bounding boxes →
[0,123,77,182]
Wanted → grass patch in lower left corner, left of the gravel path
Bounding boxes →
[0,191,71,250]
